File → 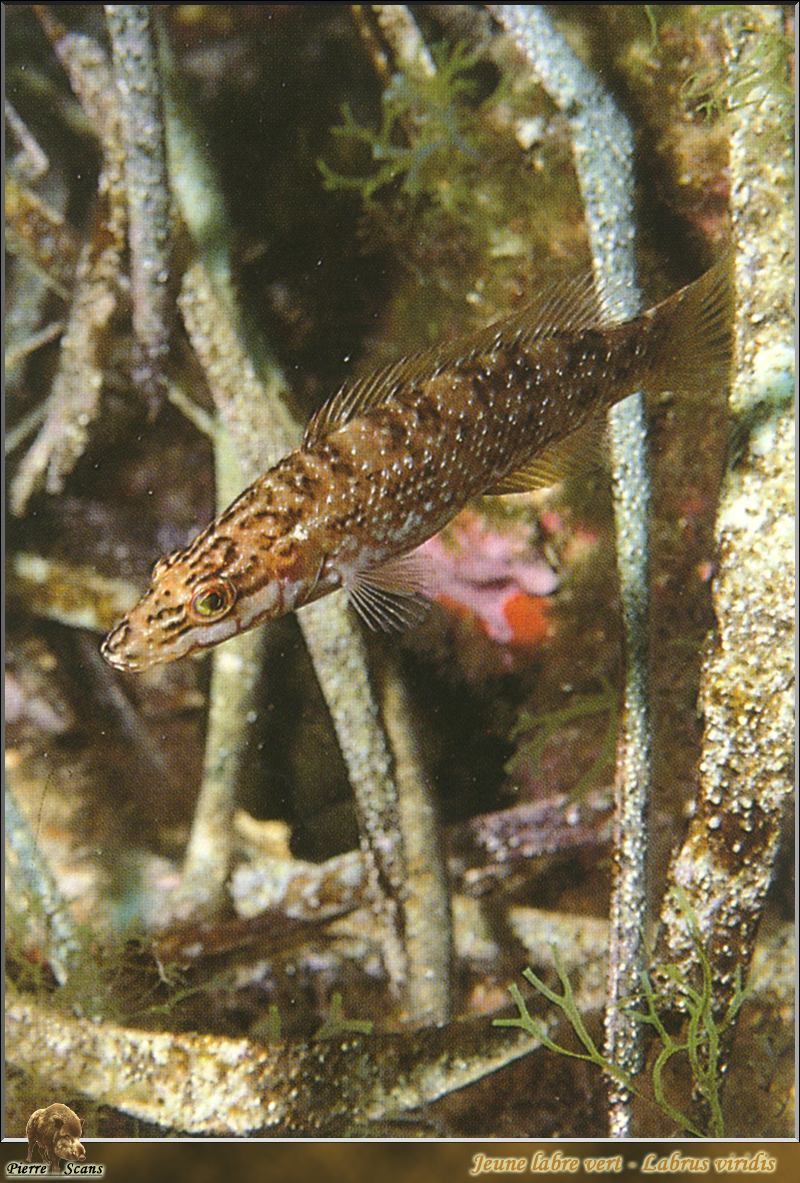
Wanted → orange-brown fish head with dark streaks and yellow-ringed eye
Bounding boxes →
[101,529,321,672]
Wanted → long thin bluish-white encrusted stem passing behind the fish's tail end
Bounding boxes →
[490,5,651,1137]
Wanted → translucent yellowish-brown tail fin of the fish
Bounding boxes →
[644,251,733,396]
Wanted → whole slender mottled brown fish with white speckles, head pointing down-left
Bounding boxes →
[101,258,731,672]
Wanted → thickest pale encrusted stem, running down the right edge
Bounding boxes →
[662,5,795,1045]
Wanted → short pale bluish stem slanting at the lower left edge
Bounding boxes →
[4,774,80,985]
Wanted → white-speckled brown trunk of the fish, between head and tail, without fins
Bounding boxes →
[300,326,643,562]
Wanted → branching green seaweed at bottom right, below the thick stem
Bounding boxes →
[492,890,747,1138]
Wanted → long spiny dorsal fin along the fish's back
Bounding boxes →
[303,272,614,448]
